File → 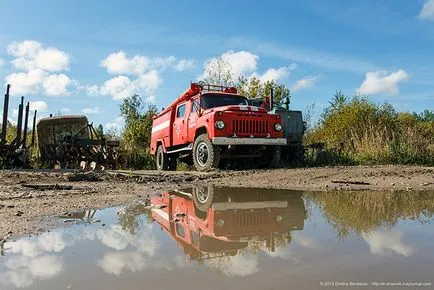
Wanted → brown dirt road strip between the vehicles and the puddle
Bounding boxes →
[0,166,434,240]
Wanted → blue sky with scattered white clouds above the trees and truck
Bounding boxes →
[0,0,434,131]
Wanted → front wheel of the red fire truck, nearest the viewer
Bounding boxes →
[193,134,220,171]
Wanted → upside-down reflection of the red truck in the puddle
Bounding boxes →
[151,186,306,261]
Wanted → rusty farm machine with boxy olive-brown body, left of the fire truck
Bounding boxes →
[37,116,119,169]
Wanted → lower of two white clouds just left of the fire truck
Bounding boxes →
[99,70,162,100]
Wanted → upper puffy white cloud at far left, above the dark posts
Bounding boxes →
[7,40,69,72]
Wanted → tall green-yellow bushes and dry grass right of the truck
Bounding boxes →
[306,92,434,165]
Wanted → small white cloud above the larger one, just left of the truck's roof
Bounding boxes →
[101,50,150,74]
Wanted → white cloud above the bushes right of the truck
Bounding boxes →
[356,69,409,95]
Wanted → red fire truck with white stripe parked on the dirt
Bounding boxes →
[150,83,287,171]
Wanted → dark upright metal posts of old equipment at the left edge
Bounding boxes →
[0,84,37,168]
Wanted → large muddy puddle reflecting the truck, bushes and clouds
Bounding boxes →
[0,187,434,290]
